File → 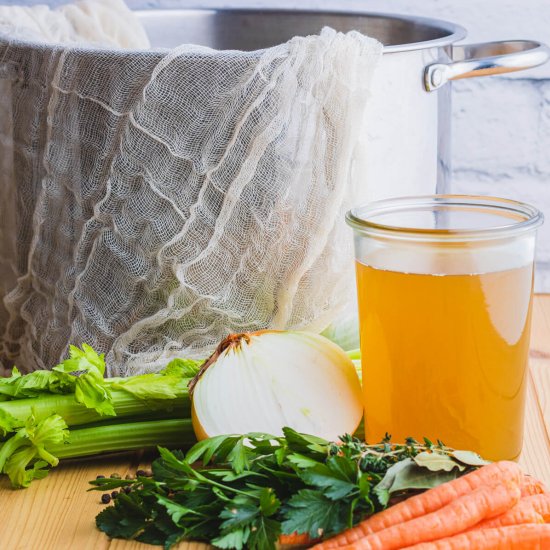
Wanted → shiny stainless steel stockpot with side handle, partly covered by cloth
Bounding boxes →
[138,10,549,200]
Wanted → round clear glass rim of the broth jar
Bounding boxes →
[346,194,544,242]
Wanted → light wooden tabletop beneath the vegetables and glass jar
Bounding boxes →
[0,295,550,550]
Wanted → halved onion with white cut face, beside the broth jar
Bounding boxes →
[192,331,363,440]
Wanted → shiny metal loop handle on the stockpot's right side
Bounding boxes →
[424,40,550,92]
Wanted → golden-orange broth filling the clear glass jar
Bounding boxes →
[356,262,533,460]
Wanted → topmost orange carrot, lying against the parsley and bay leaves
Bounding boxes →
[315,461,523,550]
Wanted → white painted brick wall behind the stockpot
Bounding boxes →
[4,0,550,292]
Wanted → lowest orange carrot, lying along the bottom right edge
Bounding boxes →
[406,524,550,550]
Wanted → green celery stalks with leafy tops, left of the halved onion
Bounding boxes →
[0,344,200,487]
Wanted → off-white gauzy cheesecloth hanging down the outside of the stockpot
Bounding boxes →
[0,9,381,375]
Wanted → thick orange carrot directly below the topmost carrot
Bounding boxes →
[338,481,521,550]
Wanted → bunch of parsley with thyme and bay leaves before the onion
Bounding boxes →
[91,428,483,550]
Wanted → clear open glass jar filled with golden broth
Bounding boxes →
[346,195,543,460]
